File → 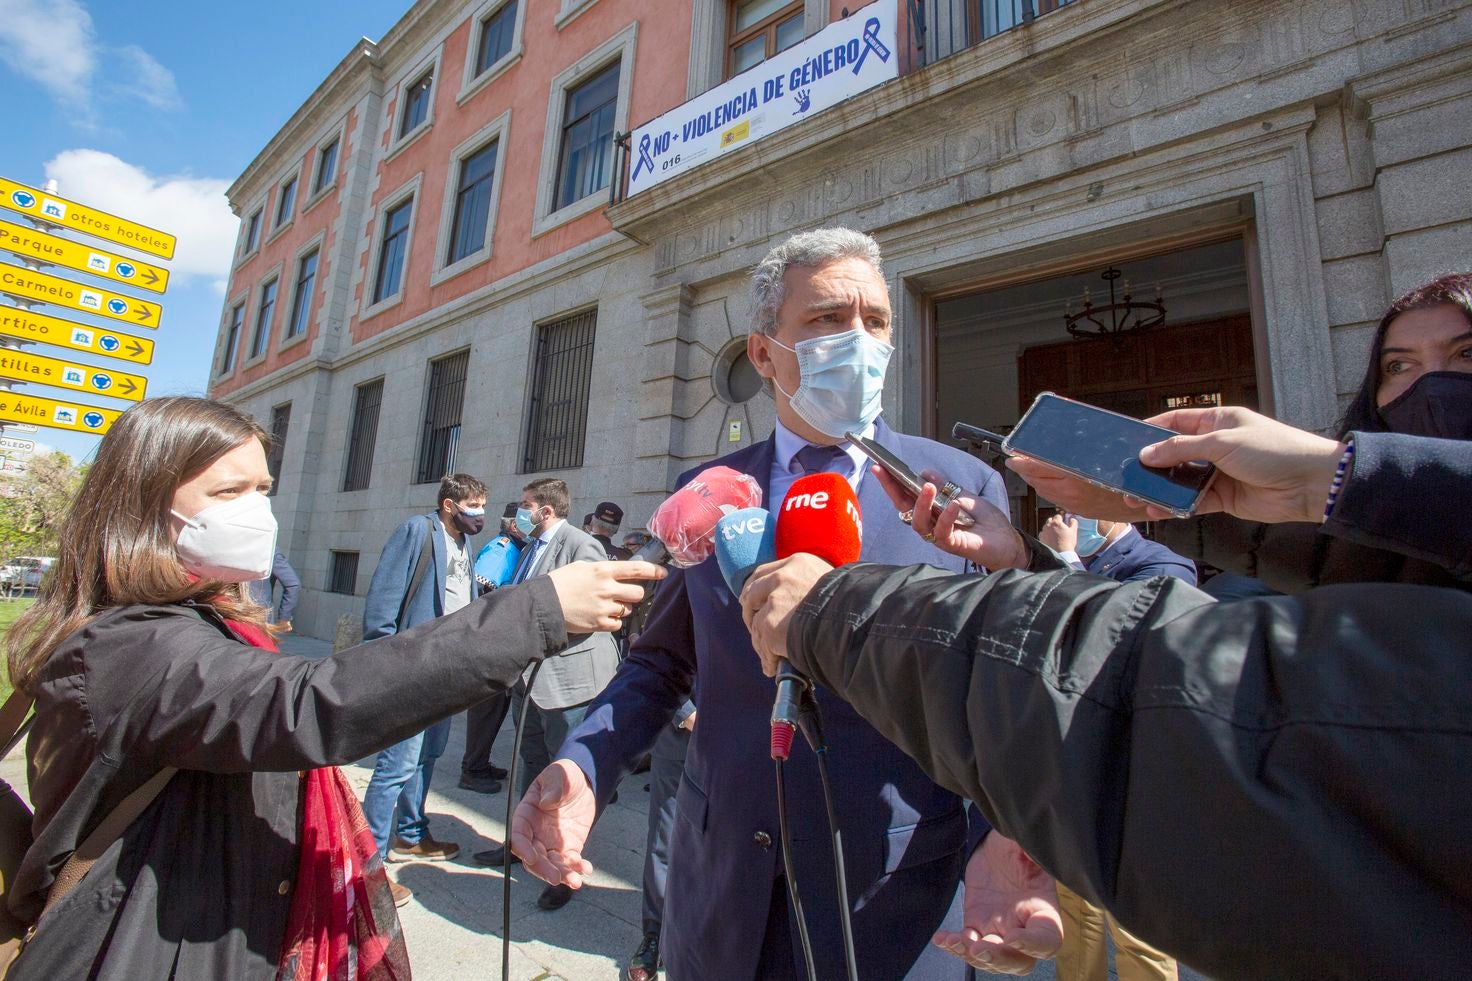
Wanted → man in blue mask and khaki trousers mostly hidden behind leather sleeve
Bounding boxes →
[1038,514,1197,981]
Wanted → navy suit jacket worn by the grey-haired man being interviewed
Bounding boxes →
[559,421,1007,981]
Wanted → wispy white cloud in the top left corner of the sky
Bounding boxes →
[0,0,184,120]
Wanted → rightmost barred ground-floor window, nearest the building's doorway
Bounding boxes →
[521,309,598,473]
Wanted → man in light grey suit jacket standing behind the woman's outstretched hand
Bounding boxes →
[475,477,618,910]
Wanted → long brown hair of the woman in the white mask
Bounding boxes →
[6,396,271,688]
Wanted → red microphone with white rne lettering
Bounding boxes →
[771,473,864,760]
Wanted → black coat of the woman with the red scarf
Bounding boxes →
[9,580,568,981]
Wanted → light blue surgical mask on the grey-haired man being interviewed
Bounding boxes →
[767,327,895,439]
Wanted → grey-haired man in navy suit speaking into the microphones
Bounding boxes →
[514,228,1057,980]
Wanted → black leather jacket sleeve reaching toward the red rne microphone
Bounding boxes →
[788,564,1472,978]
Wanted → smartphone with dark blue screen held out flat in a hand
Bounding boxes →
[1002,392,1216,517]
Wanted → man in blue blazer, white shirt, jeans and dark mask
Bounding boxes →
[364,473,486,906]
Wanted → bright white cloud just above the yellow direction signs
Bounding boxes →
[46,149,240,280]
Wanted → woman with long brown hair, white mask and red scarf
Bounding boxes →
[7,398,662,981]
